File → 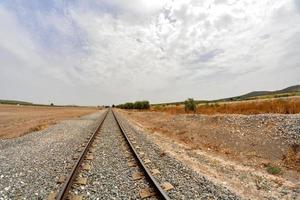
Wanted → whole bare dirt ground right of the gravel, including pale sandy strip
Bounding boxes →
[120,110,300,199]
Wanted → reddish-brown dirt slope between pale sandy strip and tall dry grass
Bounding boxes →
[121,111,300,172]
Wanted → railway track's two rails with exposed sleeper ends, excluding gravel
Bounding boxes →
[48,109,173,200]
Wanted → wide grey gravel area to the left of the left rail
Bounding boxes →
[0,112,102,200]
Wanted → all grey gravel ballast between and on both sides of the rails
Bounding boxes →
[0,109,246,200]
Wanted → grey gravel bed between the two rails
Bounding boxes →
[73,112,157,199]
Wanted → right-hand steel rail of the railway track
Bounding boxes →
[112,110,170,200]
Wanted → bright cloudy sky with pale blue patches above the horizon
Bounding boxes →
[0,0,300,105]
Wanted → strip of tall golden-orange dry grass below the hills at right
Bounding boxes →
[151,97,300,115]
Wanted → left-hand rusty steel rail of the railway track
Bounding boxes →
[55,110,109,200]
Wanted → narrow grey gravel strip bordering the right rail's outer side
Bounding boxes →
[118,111,240,200]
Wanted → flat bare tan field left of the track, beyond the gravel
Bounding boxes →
[0,104,97,139]
